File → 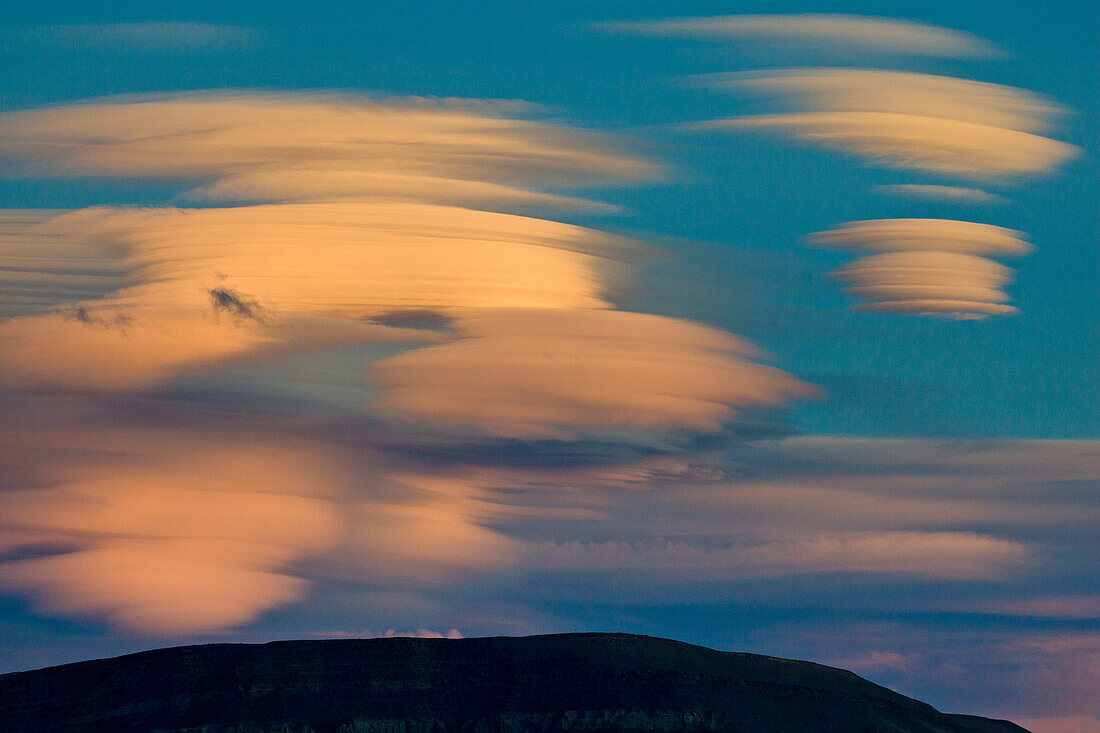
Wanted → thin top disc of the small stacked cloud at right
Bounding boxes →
[810,219,1034,256]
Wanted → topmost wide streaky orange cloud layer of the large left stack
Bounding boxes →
[0,92,658,208]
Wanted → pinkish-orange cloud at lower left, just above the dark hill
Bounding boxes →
[0,395,525,635]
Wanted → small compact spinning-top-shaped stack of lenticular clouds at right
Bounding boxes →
[811,219,1032,317]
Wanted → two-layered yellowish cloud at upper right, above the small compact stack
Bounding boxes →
[702,68,1080,180]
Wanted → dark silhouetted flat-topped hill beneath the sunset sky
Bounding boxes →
[0,634,1024,733]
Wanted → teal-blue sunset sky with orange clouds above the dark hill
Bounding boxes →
[0,0,1100,733]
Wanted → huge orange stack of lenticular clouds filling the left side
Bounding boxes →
[0,94,822,632]
